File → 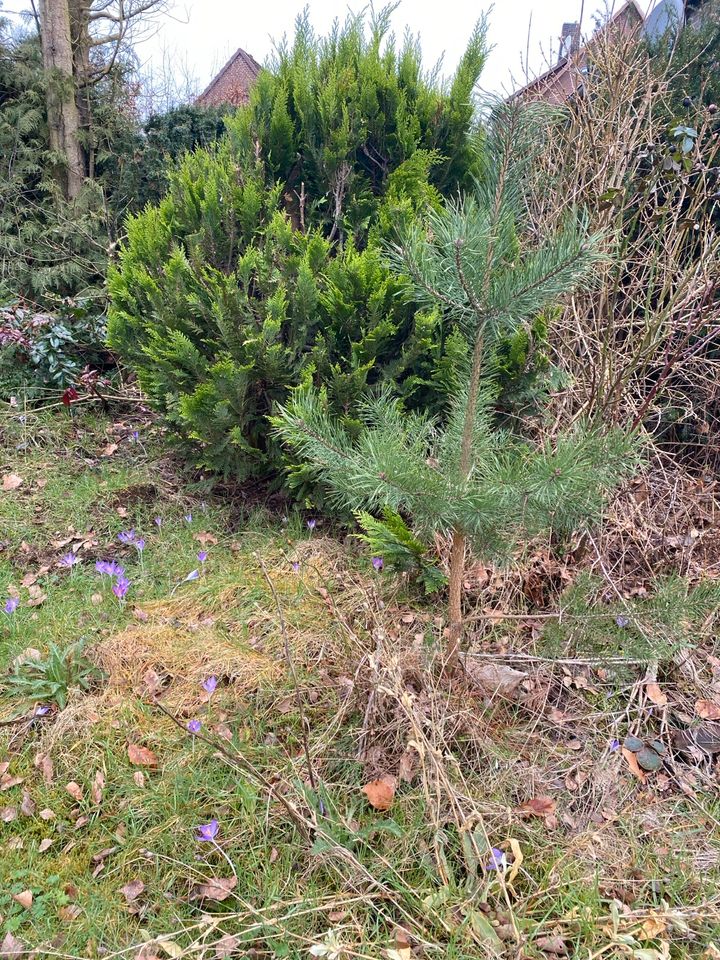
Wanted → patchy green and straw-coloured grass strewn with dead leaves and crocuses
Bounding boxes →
[0,402,720,960]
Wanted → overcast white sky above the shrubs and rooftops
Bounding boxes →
[0,0,657,93]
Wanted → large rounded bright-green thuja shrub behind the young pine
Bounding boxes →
[109,10,485,495]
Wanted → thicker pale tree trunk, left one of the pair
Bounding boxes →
[40,0,85,200]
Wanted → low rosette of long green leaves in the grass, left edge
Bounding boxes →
[4,640,103,710]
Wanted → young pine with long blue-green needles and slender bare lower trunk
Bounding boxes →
[273,103,635,664]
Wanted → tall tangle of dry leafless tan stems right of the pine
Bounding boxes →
[533,24,720,464]
